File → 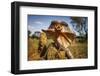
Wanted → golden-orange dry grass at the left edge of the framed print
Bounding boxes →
[28,38,41,61]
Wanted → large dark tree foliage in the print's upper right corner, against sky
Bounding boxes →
[71,17,88,36]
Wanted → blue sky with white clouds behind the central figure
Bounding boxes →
[28,15,82,33]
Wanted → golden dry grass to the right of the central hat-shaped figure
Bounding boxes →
[69,41,88,58]
